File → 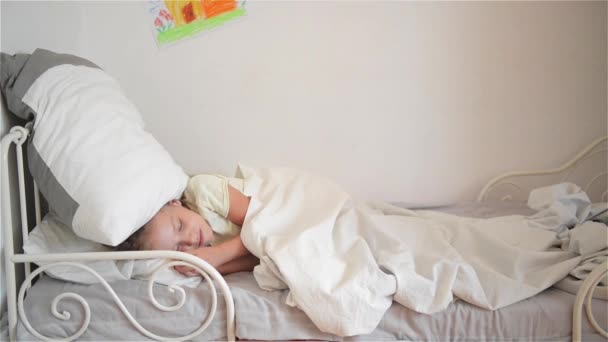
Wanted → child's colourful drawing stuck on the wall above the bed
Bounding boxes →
[149,0,245,45]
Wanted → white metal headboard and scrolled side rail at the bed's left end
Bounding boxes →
[0,126,235,341]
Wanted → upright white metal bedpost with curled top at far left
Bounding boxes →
[0,127,29,341]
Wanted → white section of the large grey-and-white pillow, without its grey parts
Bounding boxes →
[25,65,188,246]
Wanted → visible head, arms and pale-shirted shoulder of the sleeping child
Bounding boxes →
[117,175,259,276]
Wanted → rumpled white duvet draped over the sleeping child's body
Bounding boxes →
[239,166,605,336]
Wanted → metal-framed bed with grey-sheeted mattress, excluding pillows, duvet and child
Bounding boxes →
[2,123,608,341]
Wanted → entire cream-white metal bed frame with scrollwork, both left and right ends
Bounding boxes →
[0,125,608,341]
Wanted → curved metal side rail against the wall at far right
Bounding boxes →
[477,136,608,202]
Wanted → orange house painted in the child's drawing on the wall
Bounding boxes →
[165,0,236,27]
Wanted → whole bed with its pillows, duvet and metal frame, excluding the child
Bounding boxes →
[0,49,608,341]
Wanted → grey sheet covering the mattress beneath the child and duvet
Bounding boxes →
[17,203,608,341]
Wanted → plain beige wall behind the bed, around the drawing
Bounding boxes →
[1,1,607,203]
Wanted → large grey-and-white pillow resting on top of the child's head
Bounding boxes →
[0,49,188,246]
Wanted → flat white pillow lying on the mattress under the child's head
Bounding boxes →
[23,213,202,287]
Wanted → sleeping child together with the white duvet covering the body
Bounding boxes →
[116,165,608,336]
